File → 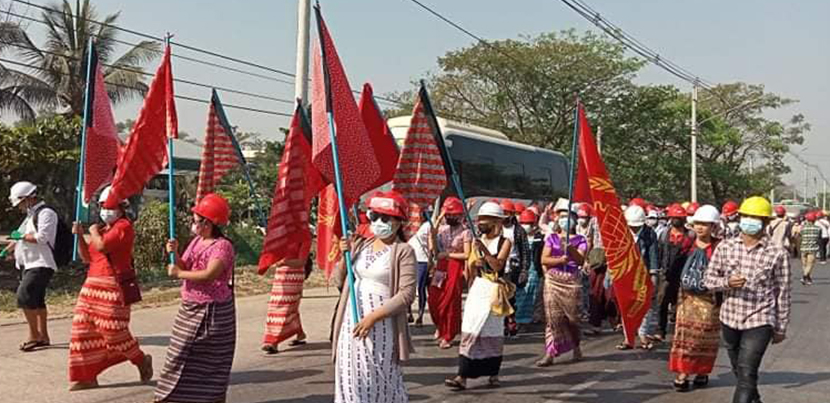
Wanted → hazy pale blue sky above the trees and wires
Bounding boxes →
[8,0,830,195]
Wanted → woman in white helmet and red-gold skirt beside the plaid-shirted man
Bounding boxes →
[669,205,720,392]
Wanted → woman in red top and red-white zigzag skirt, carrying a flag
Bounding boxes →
[69,187,153,391]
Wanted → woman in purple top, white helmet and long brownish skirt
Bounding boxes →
[536,199,588,367]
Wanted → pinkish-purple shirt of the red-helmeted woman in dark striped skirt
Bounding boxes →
[182,237,235,304]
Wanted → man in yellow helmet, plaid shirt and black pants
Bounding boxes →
[704,197,791,403]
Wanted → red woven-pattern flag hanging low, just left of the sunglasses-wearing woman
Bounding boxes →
[259,105,321,274]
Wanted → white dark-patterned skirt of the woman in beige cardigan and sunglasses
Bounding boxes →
[334,283,409,403]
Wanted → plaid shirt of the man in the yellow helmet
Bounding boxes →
[703,237,791,334]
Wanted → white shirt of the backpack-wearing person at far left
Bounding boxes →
[14,202,58,271]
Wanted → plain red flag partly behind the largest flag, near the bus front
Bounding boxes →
[360,83,399,189]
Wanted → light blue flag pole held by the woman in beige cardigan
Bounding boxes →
[314,3,361,323]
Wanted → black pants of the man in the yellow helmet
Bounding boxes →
[723,325,773,403]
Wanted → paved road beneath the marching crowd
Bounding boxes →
[0,263,830,403]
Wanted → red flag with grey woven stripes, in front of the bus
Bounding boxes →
[392,88,447,234]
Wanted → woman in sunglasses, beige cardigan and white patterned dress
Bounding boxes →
[332,192,417,403]
